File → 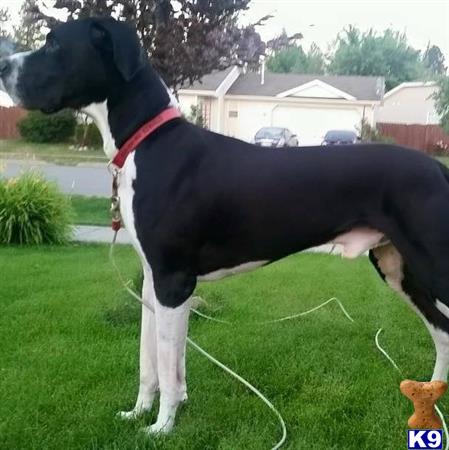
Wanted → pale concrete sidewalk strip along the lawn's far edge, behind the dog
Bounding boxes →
[73,225,341,255]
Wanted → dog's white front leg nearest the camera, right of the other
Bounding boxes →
[149,300,190,433]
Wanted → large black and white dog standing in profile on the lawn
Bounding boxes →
[0,18,449,432]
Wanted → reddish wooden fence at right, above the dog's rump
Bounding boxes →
[377,123,449,153]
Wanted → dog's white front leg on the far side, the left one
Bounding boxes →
[120,268,159,419]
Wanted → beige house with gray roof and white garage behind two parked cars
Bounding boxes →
[178,67,384,145]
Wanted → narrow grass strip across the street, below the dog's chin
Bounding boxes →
[0,139,107,165]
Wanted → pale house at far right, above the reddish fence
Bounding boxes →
[377,81,439,125]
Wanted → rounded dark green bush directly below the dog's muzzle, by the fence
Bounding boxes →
[17,110,76,143]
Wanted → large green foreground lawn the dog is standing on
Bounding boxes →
[0,245,449,450]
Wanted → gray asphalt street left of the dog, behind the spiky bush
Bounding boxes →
[1,160,111,197]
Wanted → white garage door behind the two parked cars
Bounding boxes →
[272,106,361,145]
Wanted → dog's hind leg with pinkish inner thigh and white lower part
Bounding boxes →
[369,244,449,381]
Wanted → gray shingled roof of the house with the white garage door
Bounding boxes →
[181,67,384,100]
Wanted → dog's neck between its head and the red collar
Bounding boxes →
[82,69,179,159]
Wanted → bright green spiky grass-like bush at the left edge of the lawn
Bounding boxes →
[0,172,73,245]
